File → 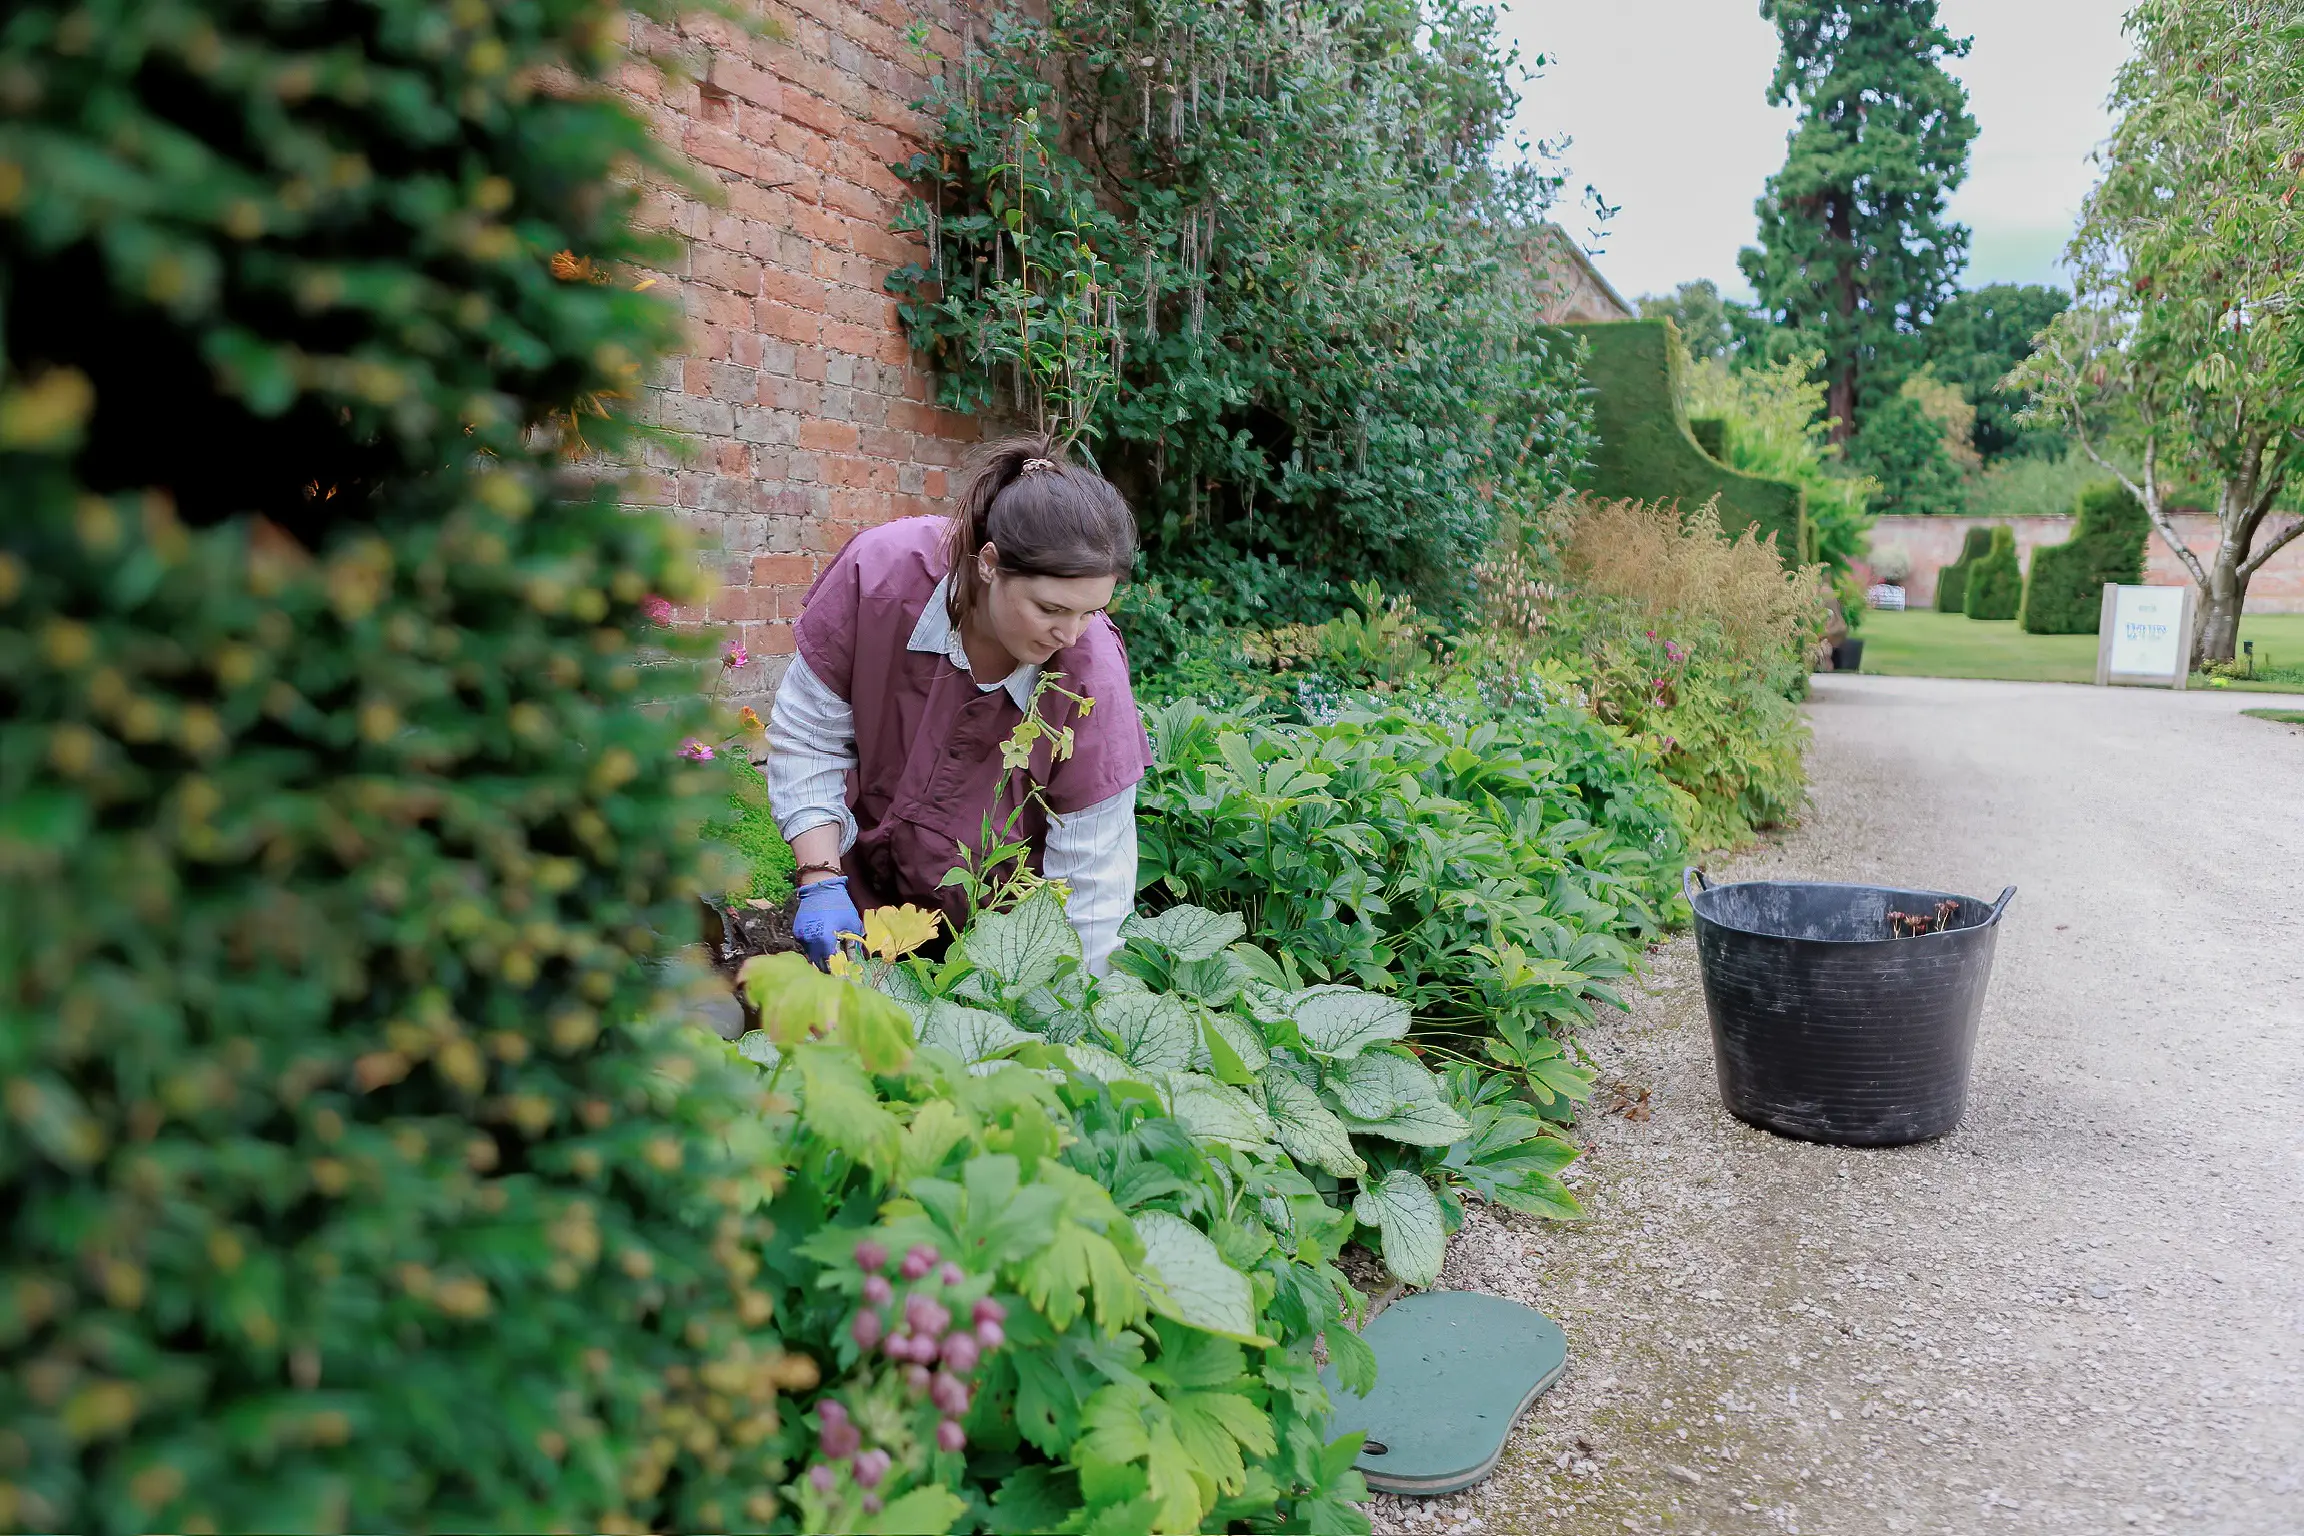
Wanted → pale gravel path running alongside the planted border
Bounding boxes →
[1375,677,2304,1536]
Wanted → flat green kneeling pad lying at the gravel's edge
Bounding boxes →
[1322,1290,1569,1497]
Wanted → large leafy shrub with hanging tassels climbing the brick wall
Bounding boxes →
[892,0,1587,638]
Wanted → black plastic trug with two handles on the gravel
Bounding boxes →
[1684,870,2016,1147]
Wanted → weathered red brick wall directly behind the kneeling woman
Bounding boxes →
[622,0,977,702]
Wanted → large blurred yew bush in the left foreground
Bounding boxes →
[0,0,816,1531]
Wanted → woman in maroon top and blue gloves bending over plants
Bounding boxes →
[767,438,1152,969]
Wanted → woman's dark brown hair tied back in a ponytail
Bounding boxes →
[947,435,1136,624]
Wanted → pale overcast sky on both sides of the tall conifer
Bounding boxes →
[1505,0,2131,297]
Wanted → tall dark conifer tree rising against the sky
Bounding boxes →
[1737,0,1977,440]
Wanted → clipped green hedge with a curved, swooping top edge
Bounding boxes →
[1562,320,1806,562]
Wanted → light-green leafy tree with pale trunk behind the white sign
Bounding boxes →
[2014,0,2304,661]
